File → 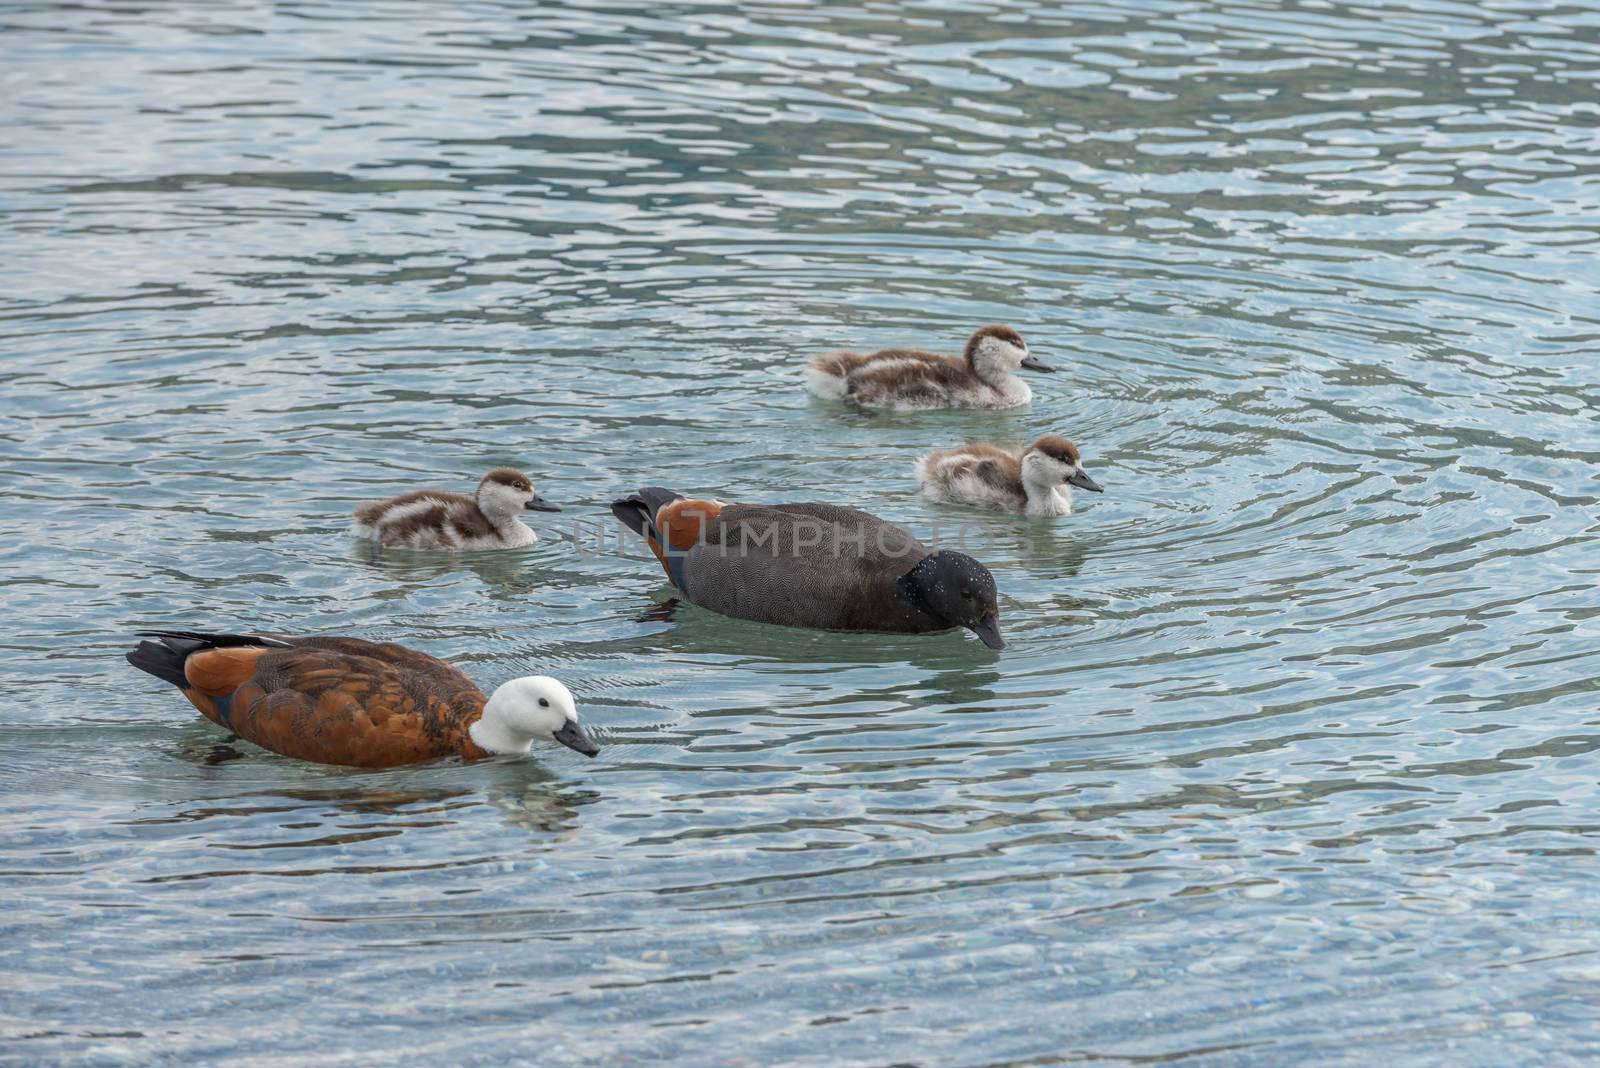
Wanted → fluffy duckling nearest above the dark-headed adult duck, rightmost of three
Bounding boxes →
[917,433,1106,516]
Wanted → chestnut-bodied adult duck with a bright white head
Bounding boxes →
[126,630,600,767]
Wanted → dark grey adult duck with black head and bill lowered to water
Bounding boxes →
[611,486,1005,649]
